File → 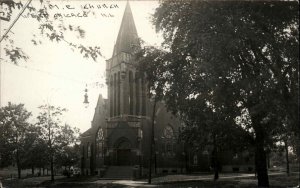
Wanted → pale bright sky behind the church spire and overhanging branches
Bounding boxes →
[0,0,162,132]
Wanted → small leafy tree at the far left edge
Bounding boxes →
[0,103,31,179]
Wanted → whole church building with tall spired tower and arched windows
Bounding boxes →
[81,2,184,176]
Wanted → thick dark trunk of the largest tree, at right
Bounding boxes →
[255,143,269,187]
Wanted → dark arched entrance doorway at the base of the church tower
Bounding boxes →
[115,138,132,166]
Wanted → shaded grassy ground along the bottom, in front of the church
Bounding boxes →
[3,173,299,188]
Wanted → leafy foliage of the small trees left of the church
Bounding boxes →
[0,103,80,178]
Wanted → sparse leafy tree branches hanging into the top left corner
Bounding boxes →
[0,0,101,64]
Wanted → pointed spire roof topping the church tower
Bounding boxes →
[113,1,140,56]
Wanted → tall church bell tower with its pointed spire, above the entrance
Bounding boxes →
[106,1,146,120]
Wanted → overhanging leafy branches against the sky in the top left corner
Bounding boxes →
[0,0,102,64]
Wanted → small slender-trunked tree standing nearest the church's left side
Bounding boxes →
[37,104,78,181]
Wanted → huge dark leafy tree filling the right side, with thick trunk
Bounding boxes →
[138,1,299,187]
